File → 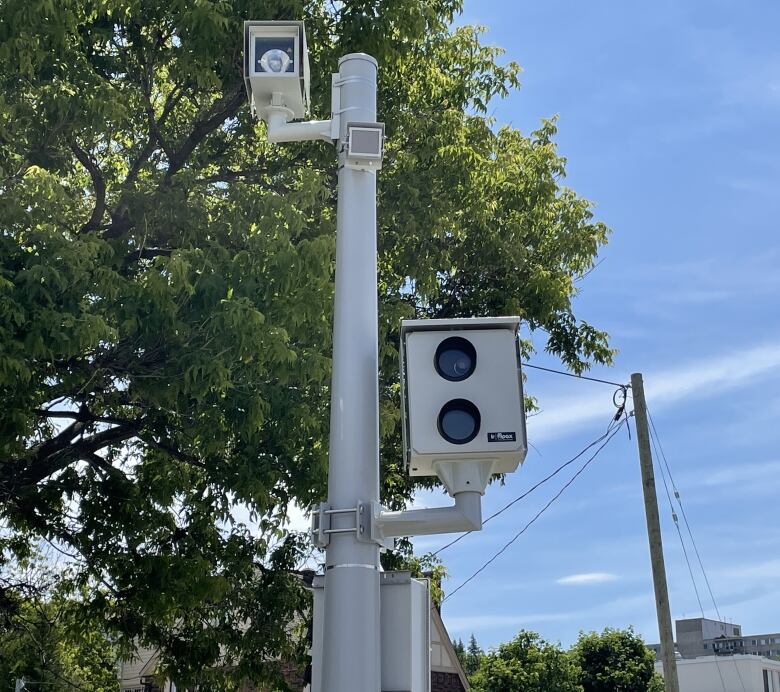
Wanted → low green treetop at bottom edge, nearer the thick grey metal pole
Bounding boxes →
[469,631,582,692]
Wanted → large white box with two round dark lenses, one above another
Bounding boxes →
[401,317,527,476]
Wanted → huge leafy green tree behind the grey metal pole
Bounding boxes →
[0,0,612,689]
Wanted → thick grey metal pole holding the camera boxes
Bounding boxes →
[323,54,381,692]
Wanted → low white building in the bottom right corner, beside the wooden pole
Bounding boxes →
[655,654,780,692]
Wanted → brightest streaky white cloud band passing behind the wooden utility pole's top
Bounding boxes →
[528,342,780,442]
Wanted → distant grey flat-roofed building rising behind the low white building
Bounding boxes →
[650,618,780,664]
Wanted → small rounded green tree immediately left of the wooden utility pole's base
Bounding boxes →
[572,628,663,692]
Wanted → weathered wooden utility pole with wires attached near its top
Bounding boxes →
[631,372,680,692]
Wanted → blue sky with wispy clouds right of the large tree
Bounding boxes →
[415,0,780,647]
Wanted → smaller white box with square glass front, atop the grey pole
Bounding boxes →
[244,21,309,120]
